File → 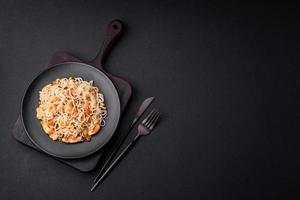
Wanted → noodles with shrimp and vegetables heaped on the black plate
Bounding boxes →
[36,77,107,143]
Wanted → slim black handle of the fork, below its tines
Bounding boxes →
[91,133,140,191]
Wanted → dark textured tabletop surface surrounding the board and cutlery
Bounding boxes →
[0,0,300,200]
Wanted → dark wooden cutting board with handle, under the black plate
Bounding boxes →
[13,20,132,172]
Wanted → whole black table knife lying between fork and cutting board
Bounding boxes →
[94,97,155,182]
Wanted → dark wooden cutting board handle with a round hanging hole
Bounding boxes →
[91,20,123,68]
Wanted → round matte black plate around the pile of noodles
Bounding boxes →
[21,62,120,159]
